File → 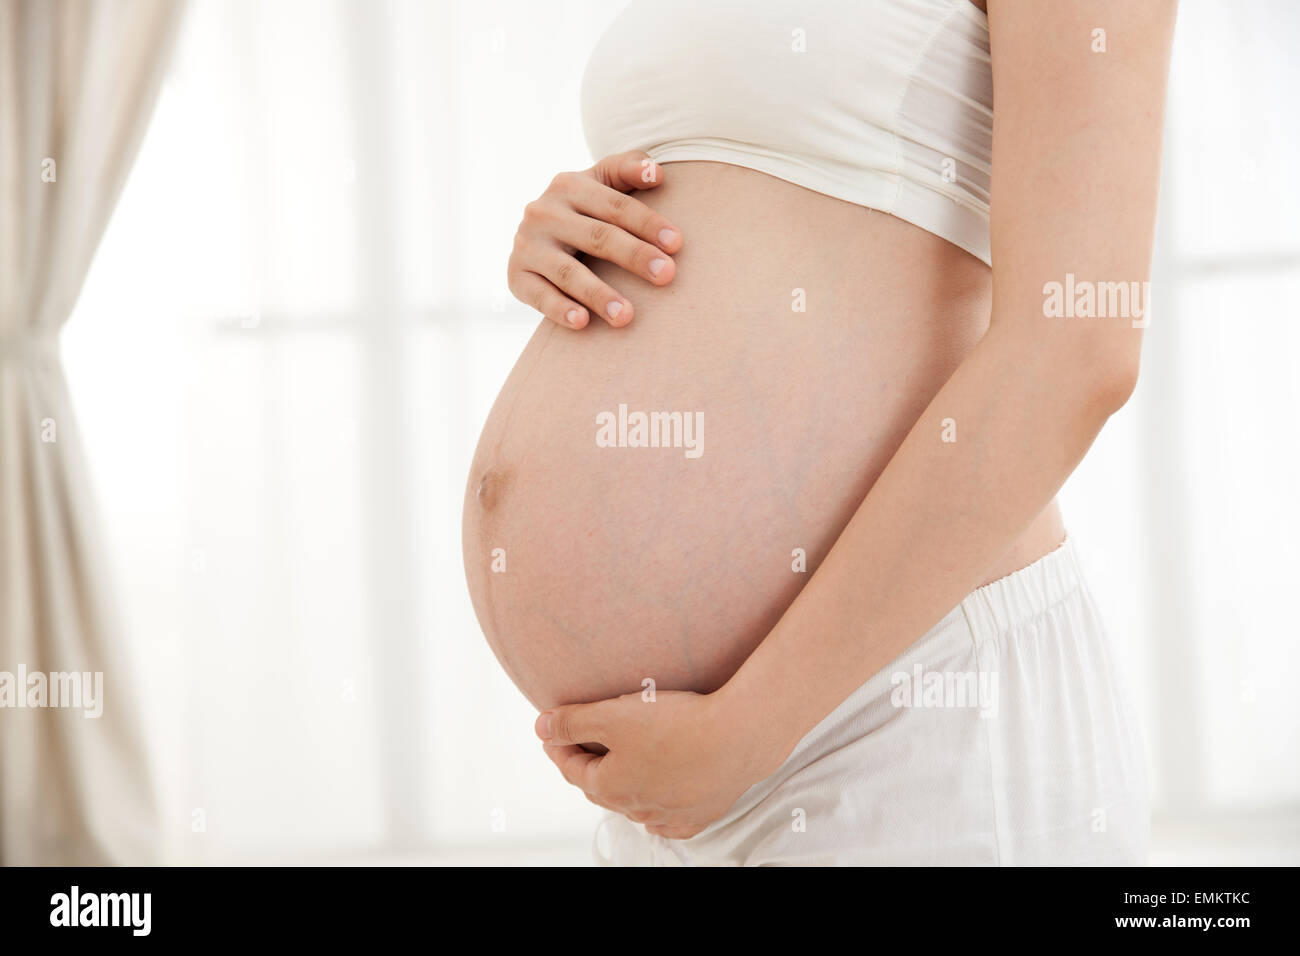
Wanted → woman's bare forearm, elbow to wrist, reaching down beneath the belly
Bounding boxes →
[719,325,1136,760]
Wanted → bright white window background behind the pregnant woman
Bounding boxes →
[64,0,1300,862]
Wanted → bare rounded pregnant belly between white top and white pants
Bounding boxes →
[464,163,1063,708]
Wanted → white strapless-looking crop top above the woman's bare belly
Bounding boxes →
[582,0,993,263]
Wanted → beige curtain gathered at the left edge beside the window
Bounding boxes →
[0,0,182,865]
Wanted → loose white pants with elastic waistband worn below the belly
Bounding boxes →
[594,541,1148,866]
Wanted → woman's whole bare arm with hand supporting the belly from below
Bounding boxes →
[536,0,1177,839]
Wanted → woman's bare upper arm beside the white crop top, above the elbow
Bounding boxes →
[988,0,1177,398]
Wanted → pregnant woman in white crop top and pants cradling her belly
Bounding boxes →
[464,0,1175,865]
